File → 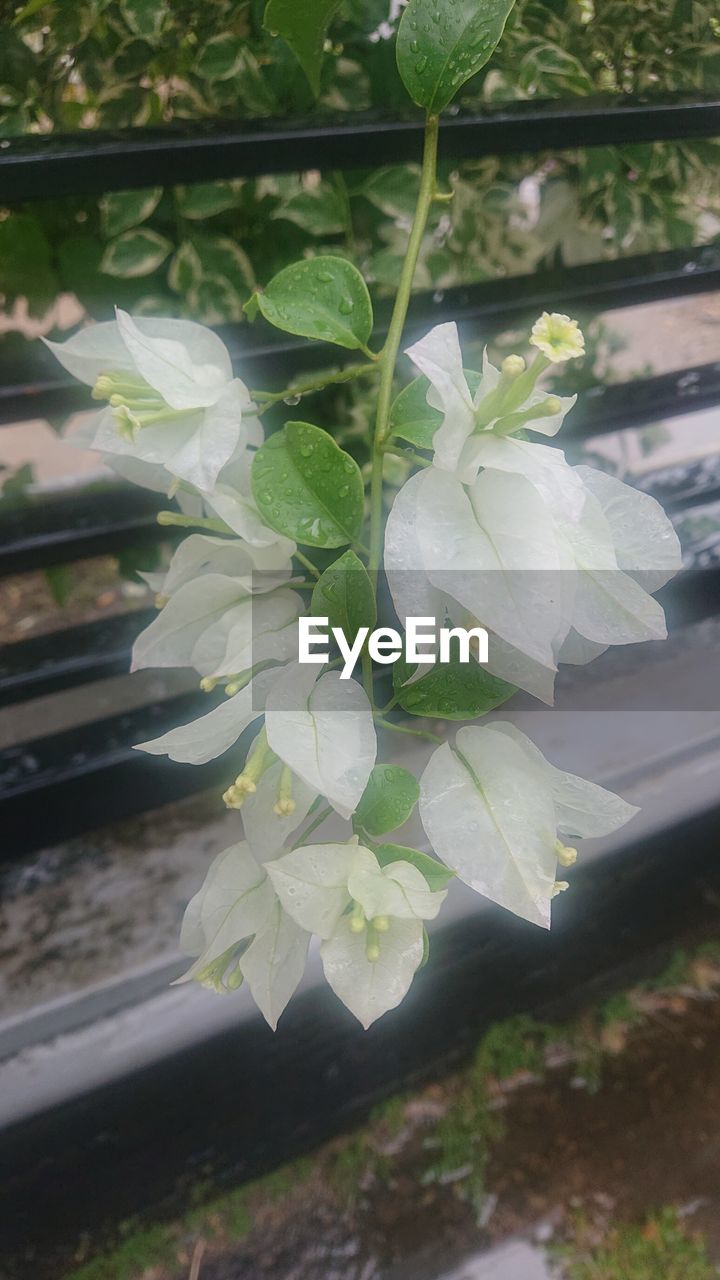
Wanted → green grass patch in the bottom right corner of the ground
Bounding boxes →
[568,1210,717,1280]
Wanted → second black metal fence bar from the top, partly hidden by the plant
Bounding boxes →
[0,244,720,425]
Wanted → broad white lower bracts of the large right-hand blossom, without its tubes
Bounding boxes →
[386,422,682,703]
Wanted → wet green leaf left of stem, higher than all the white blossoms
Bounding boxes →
[245,256,373,351]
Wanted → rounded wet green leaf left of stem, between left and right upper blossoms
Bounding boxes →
[252,422,364,547]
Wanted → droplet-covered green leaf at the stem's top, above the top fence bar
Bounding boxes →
[397,0,515,115]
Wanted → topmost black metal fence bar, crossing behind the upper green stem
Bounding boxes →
[0,93,720,204]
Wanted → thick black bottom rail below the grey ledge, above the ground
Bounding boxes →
[0,808,720,1280]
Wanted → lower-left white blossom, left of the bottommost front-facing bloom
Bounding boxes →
[178,844,310,1030]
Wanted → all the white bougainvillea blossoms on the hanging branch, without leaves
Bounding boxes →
[50,312,679,1027]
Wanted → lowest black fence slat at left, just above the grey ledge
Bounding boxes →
[0,692,249,860]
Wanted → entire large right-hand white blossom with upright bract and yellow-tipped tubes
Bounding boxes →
[384,316,680,703]
